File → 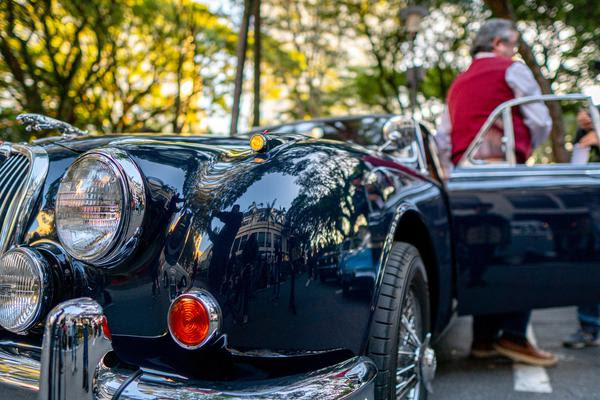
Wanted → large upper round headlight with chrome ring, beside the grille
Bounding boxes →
[56,148,146,266]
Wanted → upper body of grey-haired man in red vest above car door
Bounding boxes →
[436,18,552,165]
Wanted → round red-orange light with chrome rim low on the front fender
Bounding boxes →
[168,290,221,349]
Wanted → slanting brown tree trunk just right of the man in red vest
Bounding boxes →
[484,0,568,163]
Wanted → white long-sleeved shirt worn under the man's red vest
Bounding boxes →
[435,52,552,170]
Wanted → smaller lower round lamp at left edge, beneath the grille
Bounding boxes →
[0,247,51,333]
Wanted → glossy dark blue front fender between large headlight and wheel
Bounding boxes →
[63,140,447,363]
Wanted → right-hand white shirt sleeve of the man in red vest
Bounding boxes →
[505,62,552,148]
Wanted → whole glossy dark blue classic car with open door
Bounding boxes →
[0,96,600,399]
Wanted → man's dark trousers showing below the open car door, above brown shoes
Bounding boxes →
[473,311,531,342]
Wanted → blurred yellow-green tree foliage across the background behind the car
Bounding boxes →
[0,0,600,144]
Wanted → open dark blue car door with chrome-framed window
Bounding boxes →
[448,95,600,314]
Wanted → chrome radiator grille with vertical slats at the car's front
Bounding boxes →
[0,143,48,254]
